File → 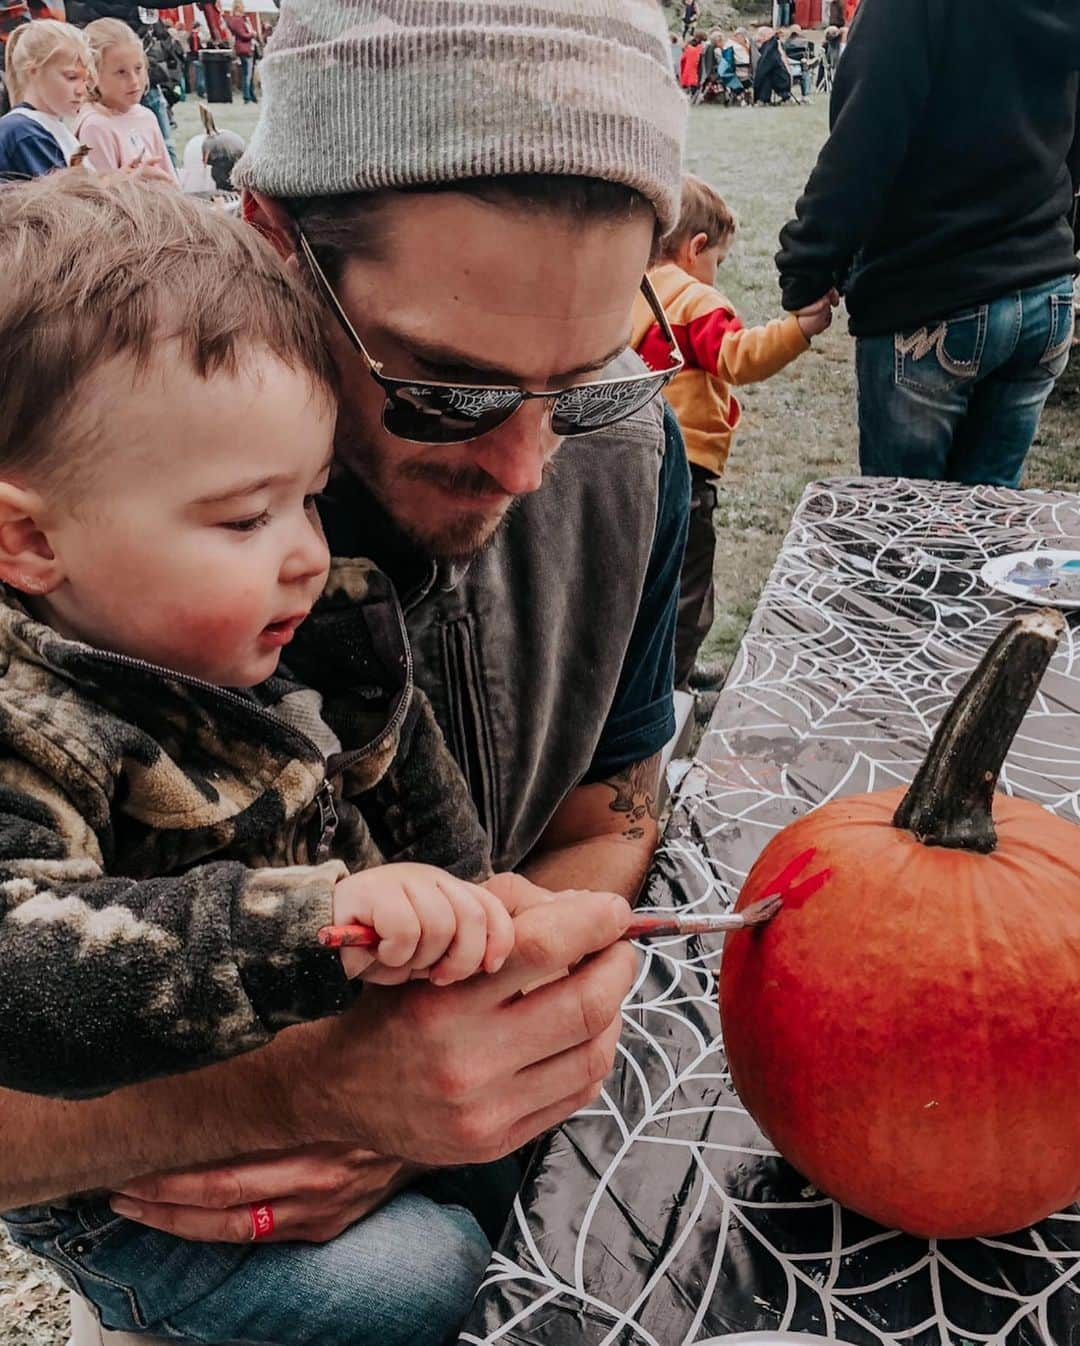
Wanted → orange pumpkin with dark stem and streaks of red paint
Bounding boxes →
[720,611,1080,1238]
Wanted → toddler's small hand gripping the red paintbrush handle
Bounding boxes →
[334,864,513,987]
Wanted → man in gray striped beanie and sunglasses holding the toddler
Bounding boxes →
[9,0,689,1346]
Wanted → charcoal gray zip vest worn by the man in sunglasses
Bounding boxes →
[329,353,665,871]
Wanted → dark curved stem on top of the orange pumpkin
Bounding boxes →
[893,607,1065,855]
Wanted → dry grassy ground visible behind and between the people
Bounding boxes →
[0,100,1080,1346]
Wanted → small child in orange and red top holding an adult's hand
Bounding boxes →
[630,175,832,688]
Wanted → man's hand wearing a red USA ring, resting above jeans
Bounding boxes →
[112,1144,412,1244]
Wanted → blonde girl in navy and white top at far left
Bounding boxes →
[0,19,93,182]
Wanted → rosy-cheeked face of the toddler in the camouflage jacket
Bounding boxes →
[35,343,335,686]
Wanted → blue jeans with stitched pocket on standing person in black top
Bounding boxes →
[855,276,1073,486]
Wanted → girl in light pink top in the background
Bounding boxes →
[75,19,176,183]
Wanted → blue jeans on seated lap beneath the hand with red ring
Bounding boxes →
[4,1191,492,1346]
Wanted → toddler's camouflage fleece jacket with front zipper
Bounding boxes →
[0,561,489,1098]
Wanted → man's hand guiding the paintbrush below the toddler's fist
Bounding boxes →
[302,892,636,1164]
